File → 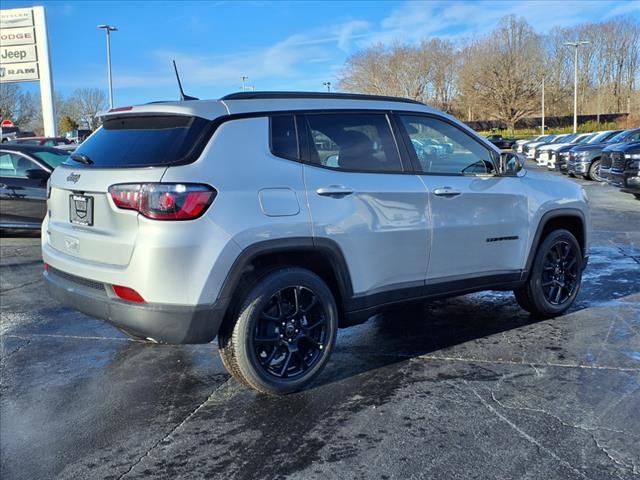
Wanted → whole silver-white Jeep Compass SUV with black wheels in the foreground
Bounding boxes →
[42,92,590,393]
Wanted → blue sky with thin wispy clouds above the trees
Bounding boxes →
[2,0,640,106]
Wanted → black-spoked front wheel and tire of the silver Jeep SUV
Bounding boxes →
[514,230,583,318]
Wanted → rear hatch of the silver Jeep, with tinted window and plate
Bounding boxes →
[47,113,211,266]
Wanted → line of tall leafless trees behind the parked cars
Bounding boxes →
[339,16,640,128]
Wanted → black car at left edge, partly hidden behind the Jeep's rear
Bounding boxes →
[0,143,69,230]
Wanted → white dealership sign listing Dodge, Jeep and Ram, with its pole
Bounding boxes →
[0,7,56,137]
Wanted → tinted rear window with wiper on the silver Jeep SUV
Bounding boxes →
[65,115,209,168]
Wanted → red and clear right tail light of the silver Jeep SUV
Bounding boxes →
[109,183,217,220]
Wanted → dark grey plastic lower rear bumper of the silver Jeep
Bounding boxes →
[44,270,224,343]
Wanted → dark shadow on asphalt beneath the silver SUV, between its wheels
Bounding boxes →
[314,292,542,387]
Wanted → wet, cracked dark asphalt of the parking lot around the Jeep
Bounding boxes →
[0,163,640,480]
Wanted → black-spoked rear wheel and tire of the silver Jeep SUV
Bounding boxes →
[218,267,338,395]
